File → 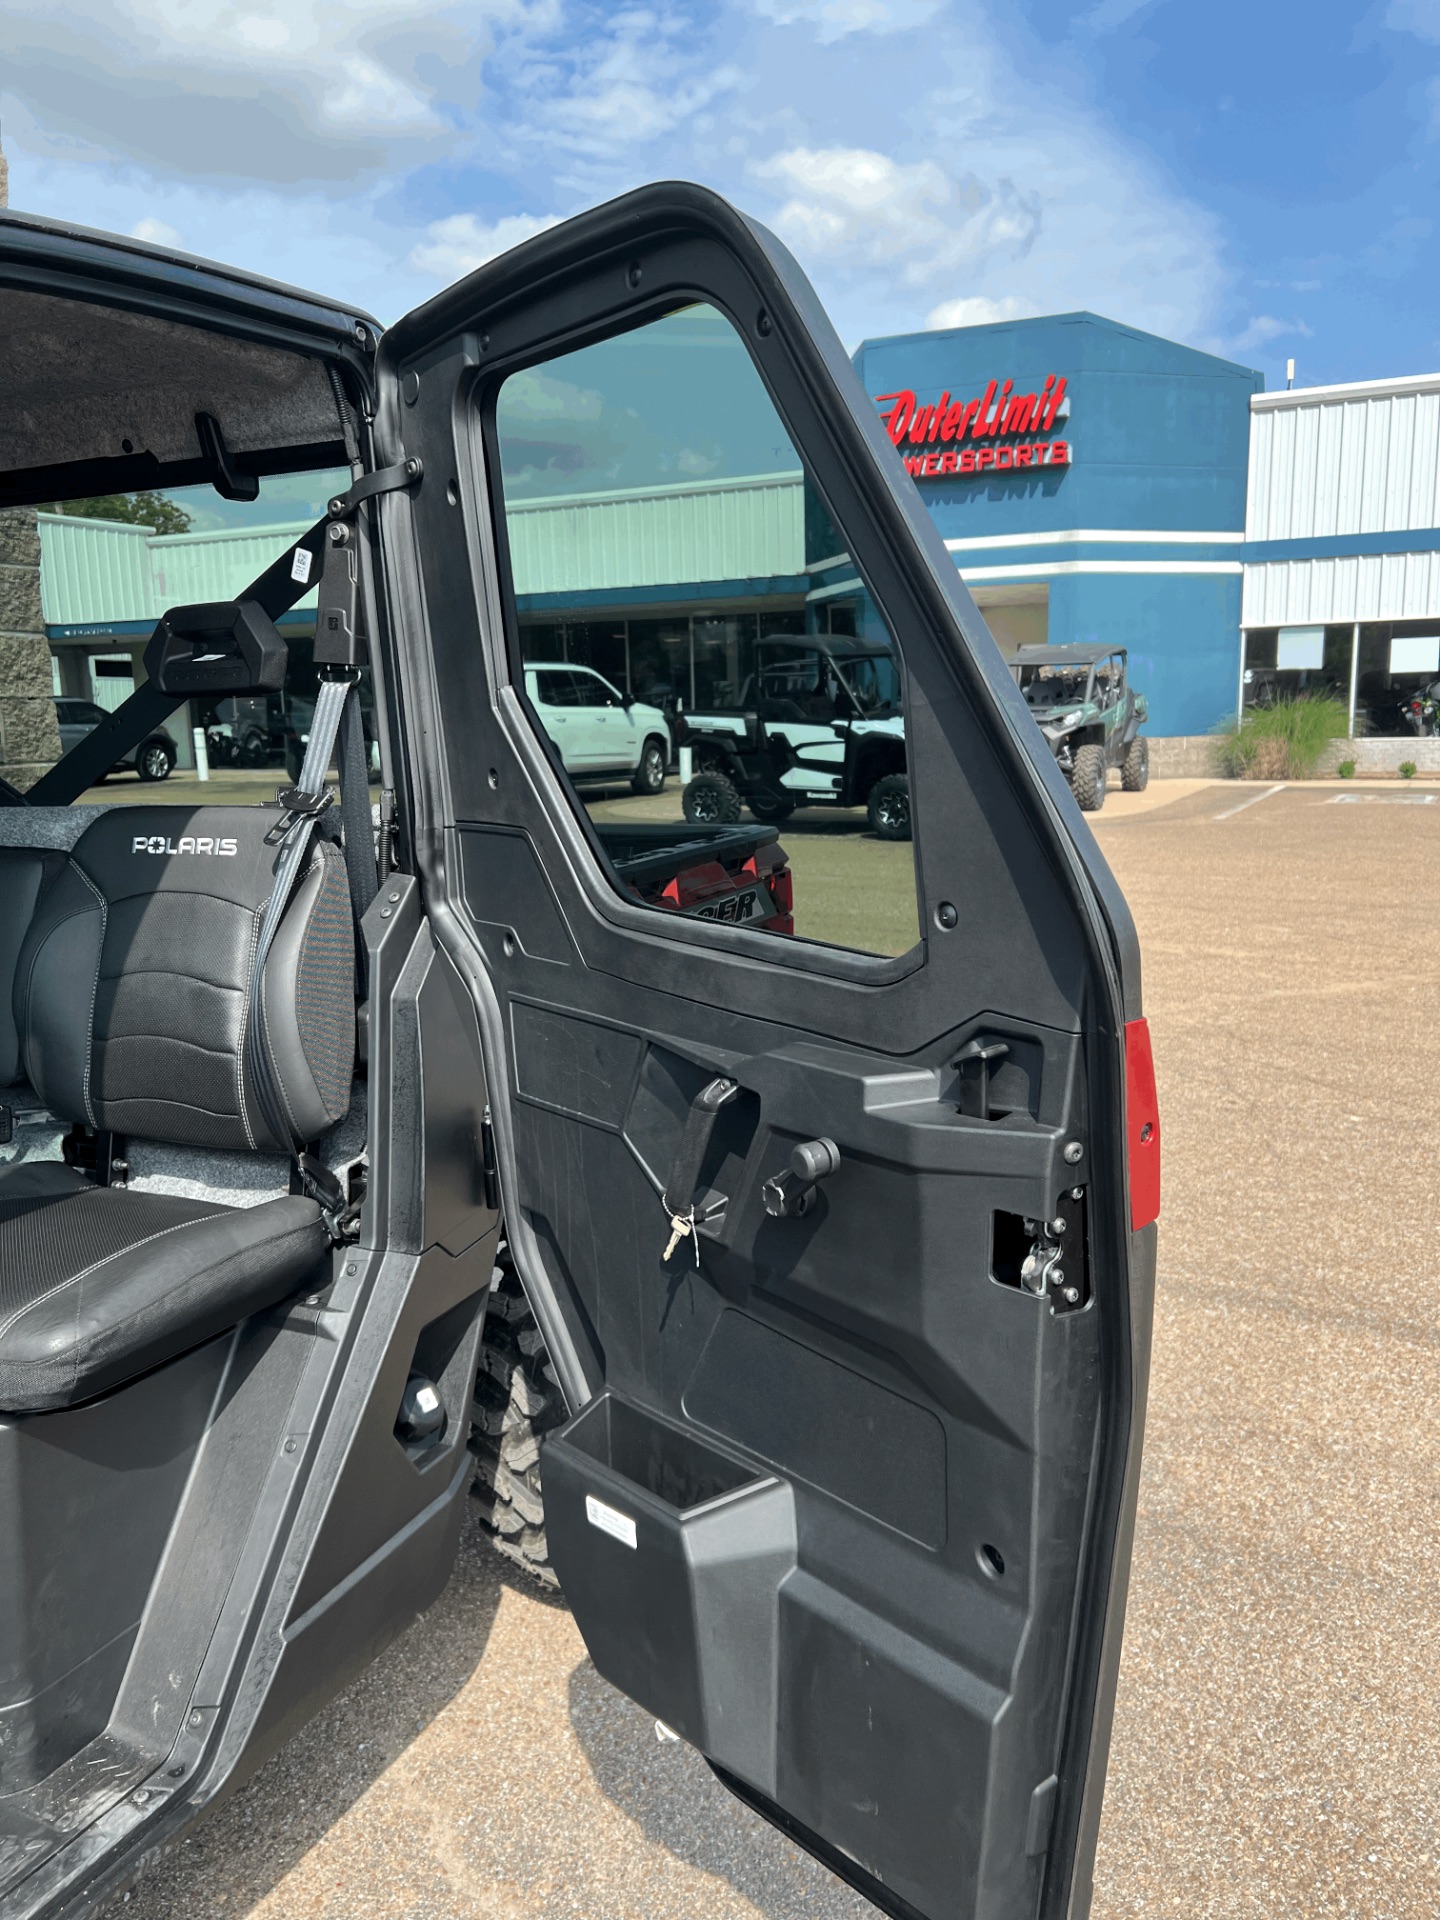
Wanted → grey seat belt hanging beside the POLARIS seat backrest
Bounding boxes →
[246,668,360,1233]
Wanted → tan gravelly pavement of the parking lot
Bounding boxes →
[115,781,1440,1920]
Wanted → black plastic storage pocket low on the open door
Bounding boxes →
[541,1392,795,1793]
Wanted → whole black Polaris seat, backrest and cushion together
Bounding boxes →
[0,806,355,1411]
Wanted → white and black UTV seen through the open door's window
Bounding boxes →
[680,634,910,841]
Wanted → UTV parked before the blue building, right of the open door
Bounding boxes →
[1010,647,1150,814]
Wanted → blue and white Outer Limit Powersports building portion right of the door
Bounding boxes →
[854,313,1440,758]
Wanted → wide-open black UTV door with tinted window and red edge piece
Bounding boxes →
[380,184,1158,1920]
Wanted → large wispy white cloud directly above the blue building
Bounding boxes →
[747,0,1227,340]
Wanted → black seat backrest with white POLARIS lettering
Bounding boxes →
[16,806,355,1152]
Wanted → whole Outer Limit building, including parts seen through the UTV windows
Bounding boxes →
[30,313,1440,770]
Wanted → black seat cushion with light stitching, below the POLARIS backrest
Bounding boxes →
[0,1162,330,1413]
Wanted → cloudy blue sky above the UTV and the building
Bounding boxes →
[0,0,1440,386]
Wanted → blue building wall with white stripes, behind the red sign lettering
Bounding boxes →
[854,313,1263,733]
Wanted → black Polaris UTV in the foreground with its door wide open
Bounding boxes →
[0,182,1160,1920]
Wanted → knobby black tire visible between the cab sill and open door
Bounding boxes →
[470,1244,568,1588]
